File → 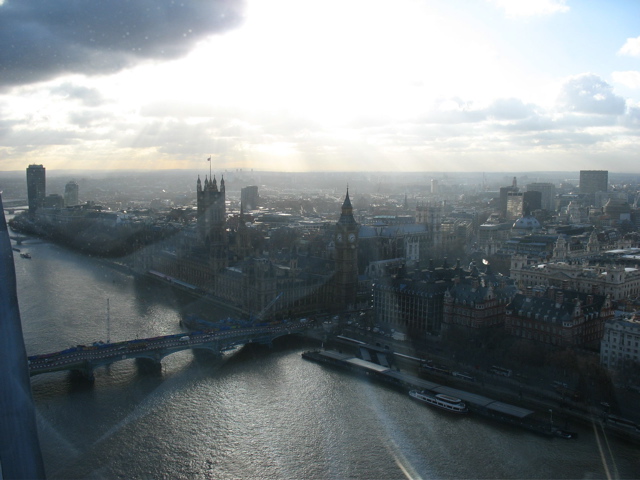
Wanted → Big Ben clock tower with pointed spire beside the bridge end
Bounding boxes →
[334,188,359,310]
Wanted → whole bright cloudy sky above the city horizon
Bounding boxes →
[0,0,640,173]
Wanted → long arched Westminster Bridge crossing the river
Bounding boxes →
[28,322,311,379]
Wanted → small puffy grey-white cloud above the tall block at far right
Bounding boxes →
[558,73,626,115]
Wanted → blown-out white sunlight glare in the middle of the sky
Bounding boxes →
[107,0,510,126]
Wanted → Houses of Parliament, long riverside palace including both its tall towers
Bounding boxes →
[134,172,359,318]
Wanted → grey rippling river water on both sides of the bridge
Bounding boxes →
[14,232,640,479]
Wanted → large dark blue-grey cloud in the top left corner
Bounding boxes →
[0,0,244,87]
